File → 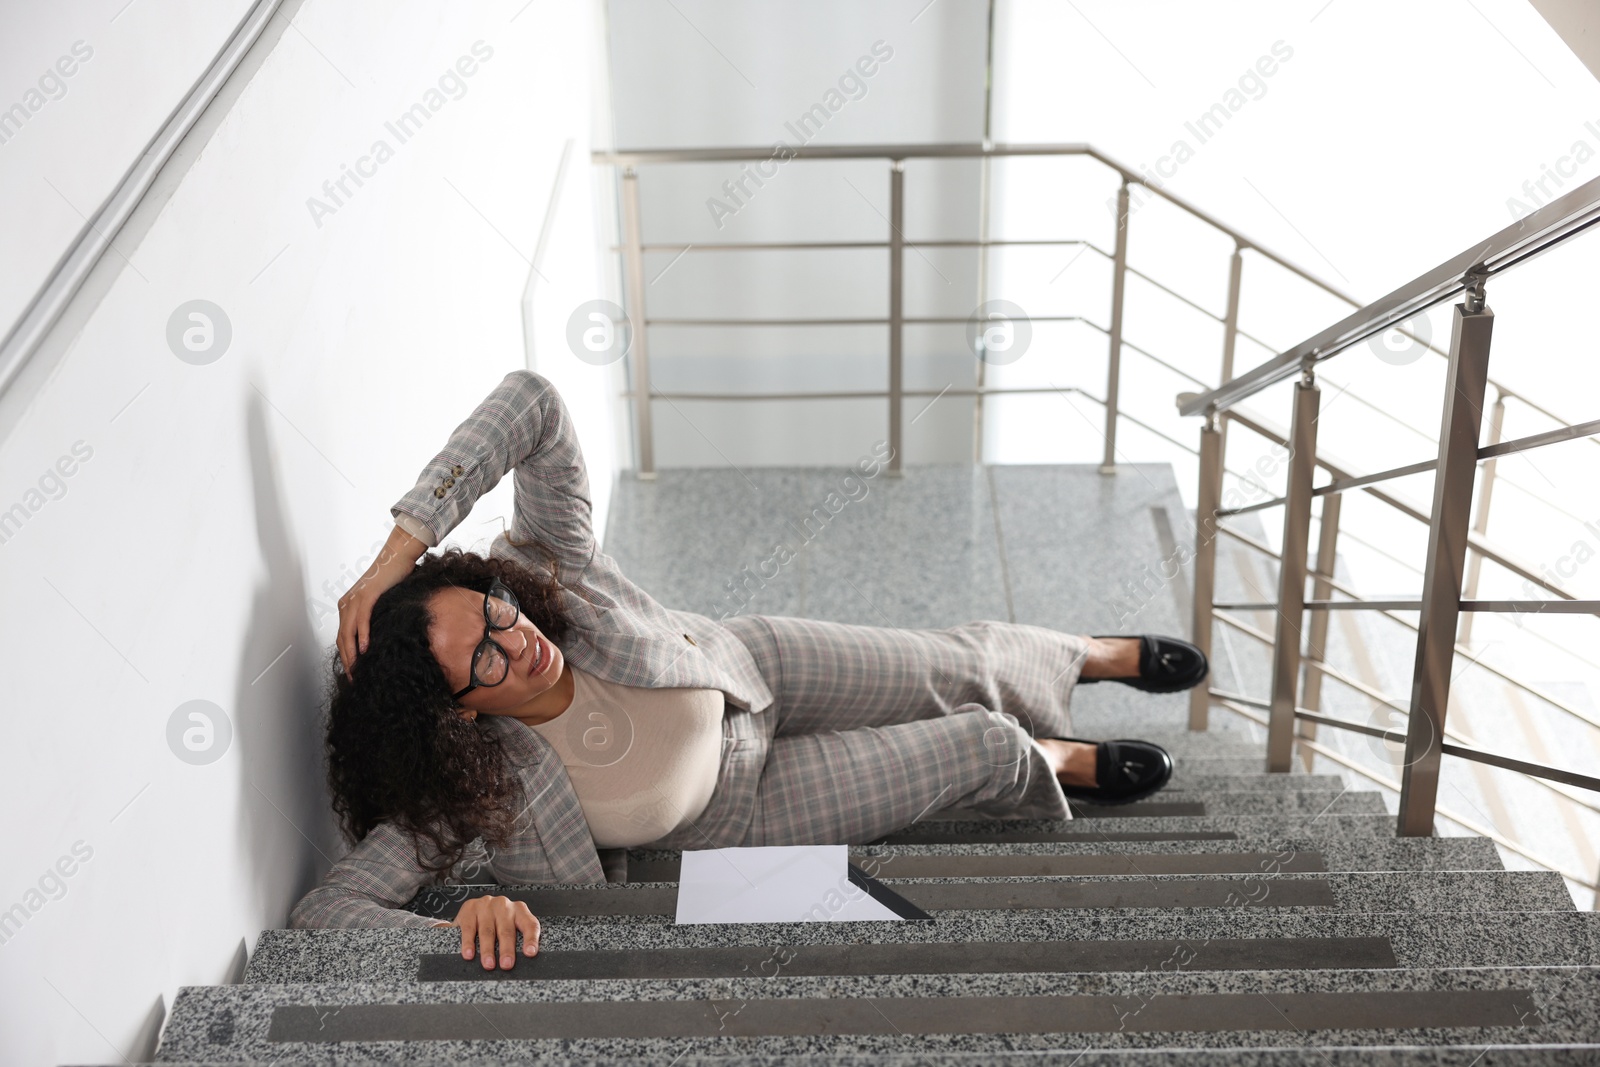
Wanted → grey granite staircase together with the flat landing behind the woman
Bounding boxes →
[140,464,1600,1067]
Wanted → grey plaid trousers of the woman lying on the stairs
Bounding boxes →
[636,616,1088,848]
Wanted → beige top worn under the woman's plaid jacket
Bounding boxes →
[533,664,723,848]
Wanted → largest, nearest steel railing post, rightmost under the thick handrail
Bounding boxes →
[1397,279,1494,837]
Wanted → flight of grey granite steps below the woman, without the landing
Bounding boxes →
[158,734,1600,1067]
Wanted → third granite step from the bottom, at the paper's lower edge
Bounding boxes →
[408,870,1573,925]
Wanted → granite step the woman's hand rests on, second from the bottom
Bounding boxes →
[243,909,1600,984]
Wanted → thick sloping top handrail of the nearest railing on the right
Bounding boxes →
[1179,178,1600,414]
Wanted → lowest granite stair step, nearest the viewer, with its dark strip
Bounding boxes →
[158,966,1600,1064]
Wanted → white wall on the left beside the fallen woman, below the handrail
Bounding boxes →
[0,0,616,1064]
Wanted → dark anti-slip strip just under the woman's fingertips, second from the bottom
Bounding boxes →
[416,937,1398,982]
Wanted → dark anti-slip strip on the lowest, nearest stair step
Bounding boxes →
[267,989,1544,1045]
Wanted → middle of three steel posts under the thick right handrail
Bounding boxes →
[1267,362,1322,773]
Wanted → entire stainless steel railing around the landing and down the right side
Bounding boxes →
[594,142,1600,883]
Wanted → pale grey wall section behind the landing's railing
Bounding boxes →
[608,0,987,467]
